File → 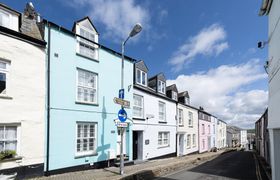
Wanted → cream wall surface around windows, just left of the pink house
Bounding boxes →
[177,103,199,155]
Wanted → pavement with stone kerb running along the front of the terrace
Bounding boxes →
[30,149,232,180]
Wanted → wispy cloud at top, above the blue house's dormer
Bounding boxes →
[71,0,150,41]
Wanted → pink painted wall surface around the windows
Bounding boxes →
[198,119,211,153]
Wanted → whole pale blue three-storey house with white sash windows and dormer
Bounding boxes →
[44,17,134,173]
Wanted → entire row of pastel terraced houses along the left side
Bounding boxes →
[0,4,226,178]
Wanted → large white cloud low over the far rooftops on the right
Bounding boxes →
[167,59,268,128]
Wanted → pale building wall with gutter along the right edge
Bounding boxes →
[259,0,280,180]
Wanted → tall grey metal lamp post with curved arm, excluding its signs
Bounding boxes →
[120,23,142,175]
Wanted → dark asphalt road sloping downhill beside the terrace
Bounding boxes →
[157,151,268,180]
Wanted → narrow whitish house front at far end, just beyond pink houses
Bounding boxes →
[217,120,227,149]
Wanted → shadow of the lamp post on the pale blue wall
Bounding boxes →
[97,96,111,162]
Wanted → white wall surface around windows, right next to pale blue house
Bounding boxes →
[132,88,176,160]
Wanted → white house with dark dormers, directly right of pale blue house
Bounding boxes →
[132,61,176,160]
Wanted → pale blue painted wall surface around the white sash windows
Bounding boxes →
[45,27,133,170]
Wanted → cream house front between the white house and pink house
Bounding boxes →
[177,103,198,156]
